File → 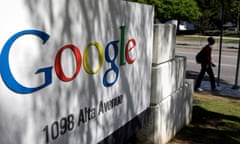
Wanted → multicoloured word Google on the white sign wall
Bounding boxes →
[0,26,136,94]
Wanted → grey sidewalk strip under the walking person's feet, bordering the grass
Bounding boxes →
[197,81,240,99]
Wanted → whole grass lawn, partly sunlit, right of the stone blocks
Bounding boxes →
[169,93,240,144]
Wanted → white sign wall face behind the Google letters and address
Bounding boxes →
[0,0,153,144]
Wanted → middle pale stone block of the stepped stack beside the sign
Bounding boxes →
[151,57,186,104]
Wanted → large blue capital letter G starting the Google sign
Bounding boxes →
[0,30,52,94]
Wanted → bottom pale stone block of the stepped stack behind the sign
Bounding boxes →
[137,80,193,144]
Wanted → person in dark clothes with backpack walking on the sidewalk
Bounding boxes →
[194,37,217,91]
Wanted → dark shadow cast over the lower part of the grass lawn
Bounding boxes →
[172,106,240,144]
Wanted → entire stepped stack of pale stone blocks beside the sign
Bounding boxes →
[137,24,193,144]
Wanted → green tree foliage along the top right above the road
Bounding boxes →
[129,0,240,30]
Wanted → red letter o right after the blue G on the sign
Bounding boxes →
[54,44,82,82]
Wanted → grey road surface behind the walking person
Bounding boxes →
[176,44,238,85]
